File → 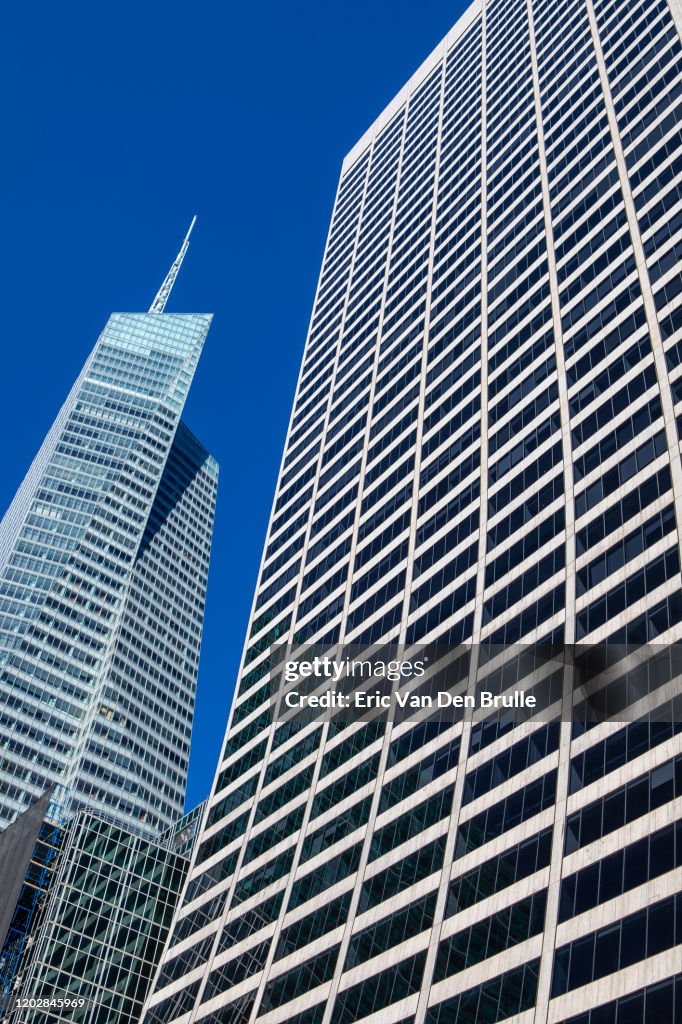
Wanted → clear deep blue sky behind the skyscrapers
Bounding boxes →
[0,0,466,806]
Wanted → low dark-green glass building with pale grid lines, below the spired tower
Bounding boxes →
[3,811,193,1024]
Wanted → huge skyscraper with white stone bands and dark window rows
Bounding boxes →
[143,0,682,1024]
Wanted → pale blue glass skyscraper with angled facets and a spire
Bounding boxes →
[0,222,218,836]
